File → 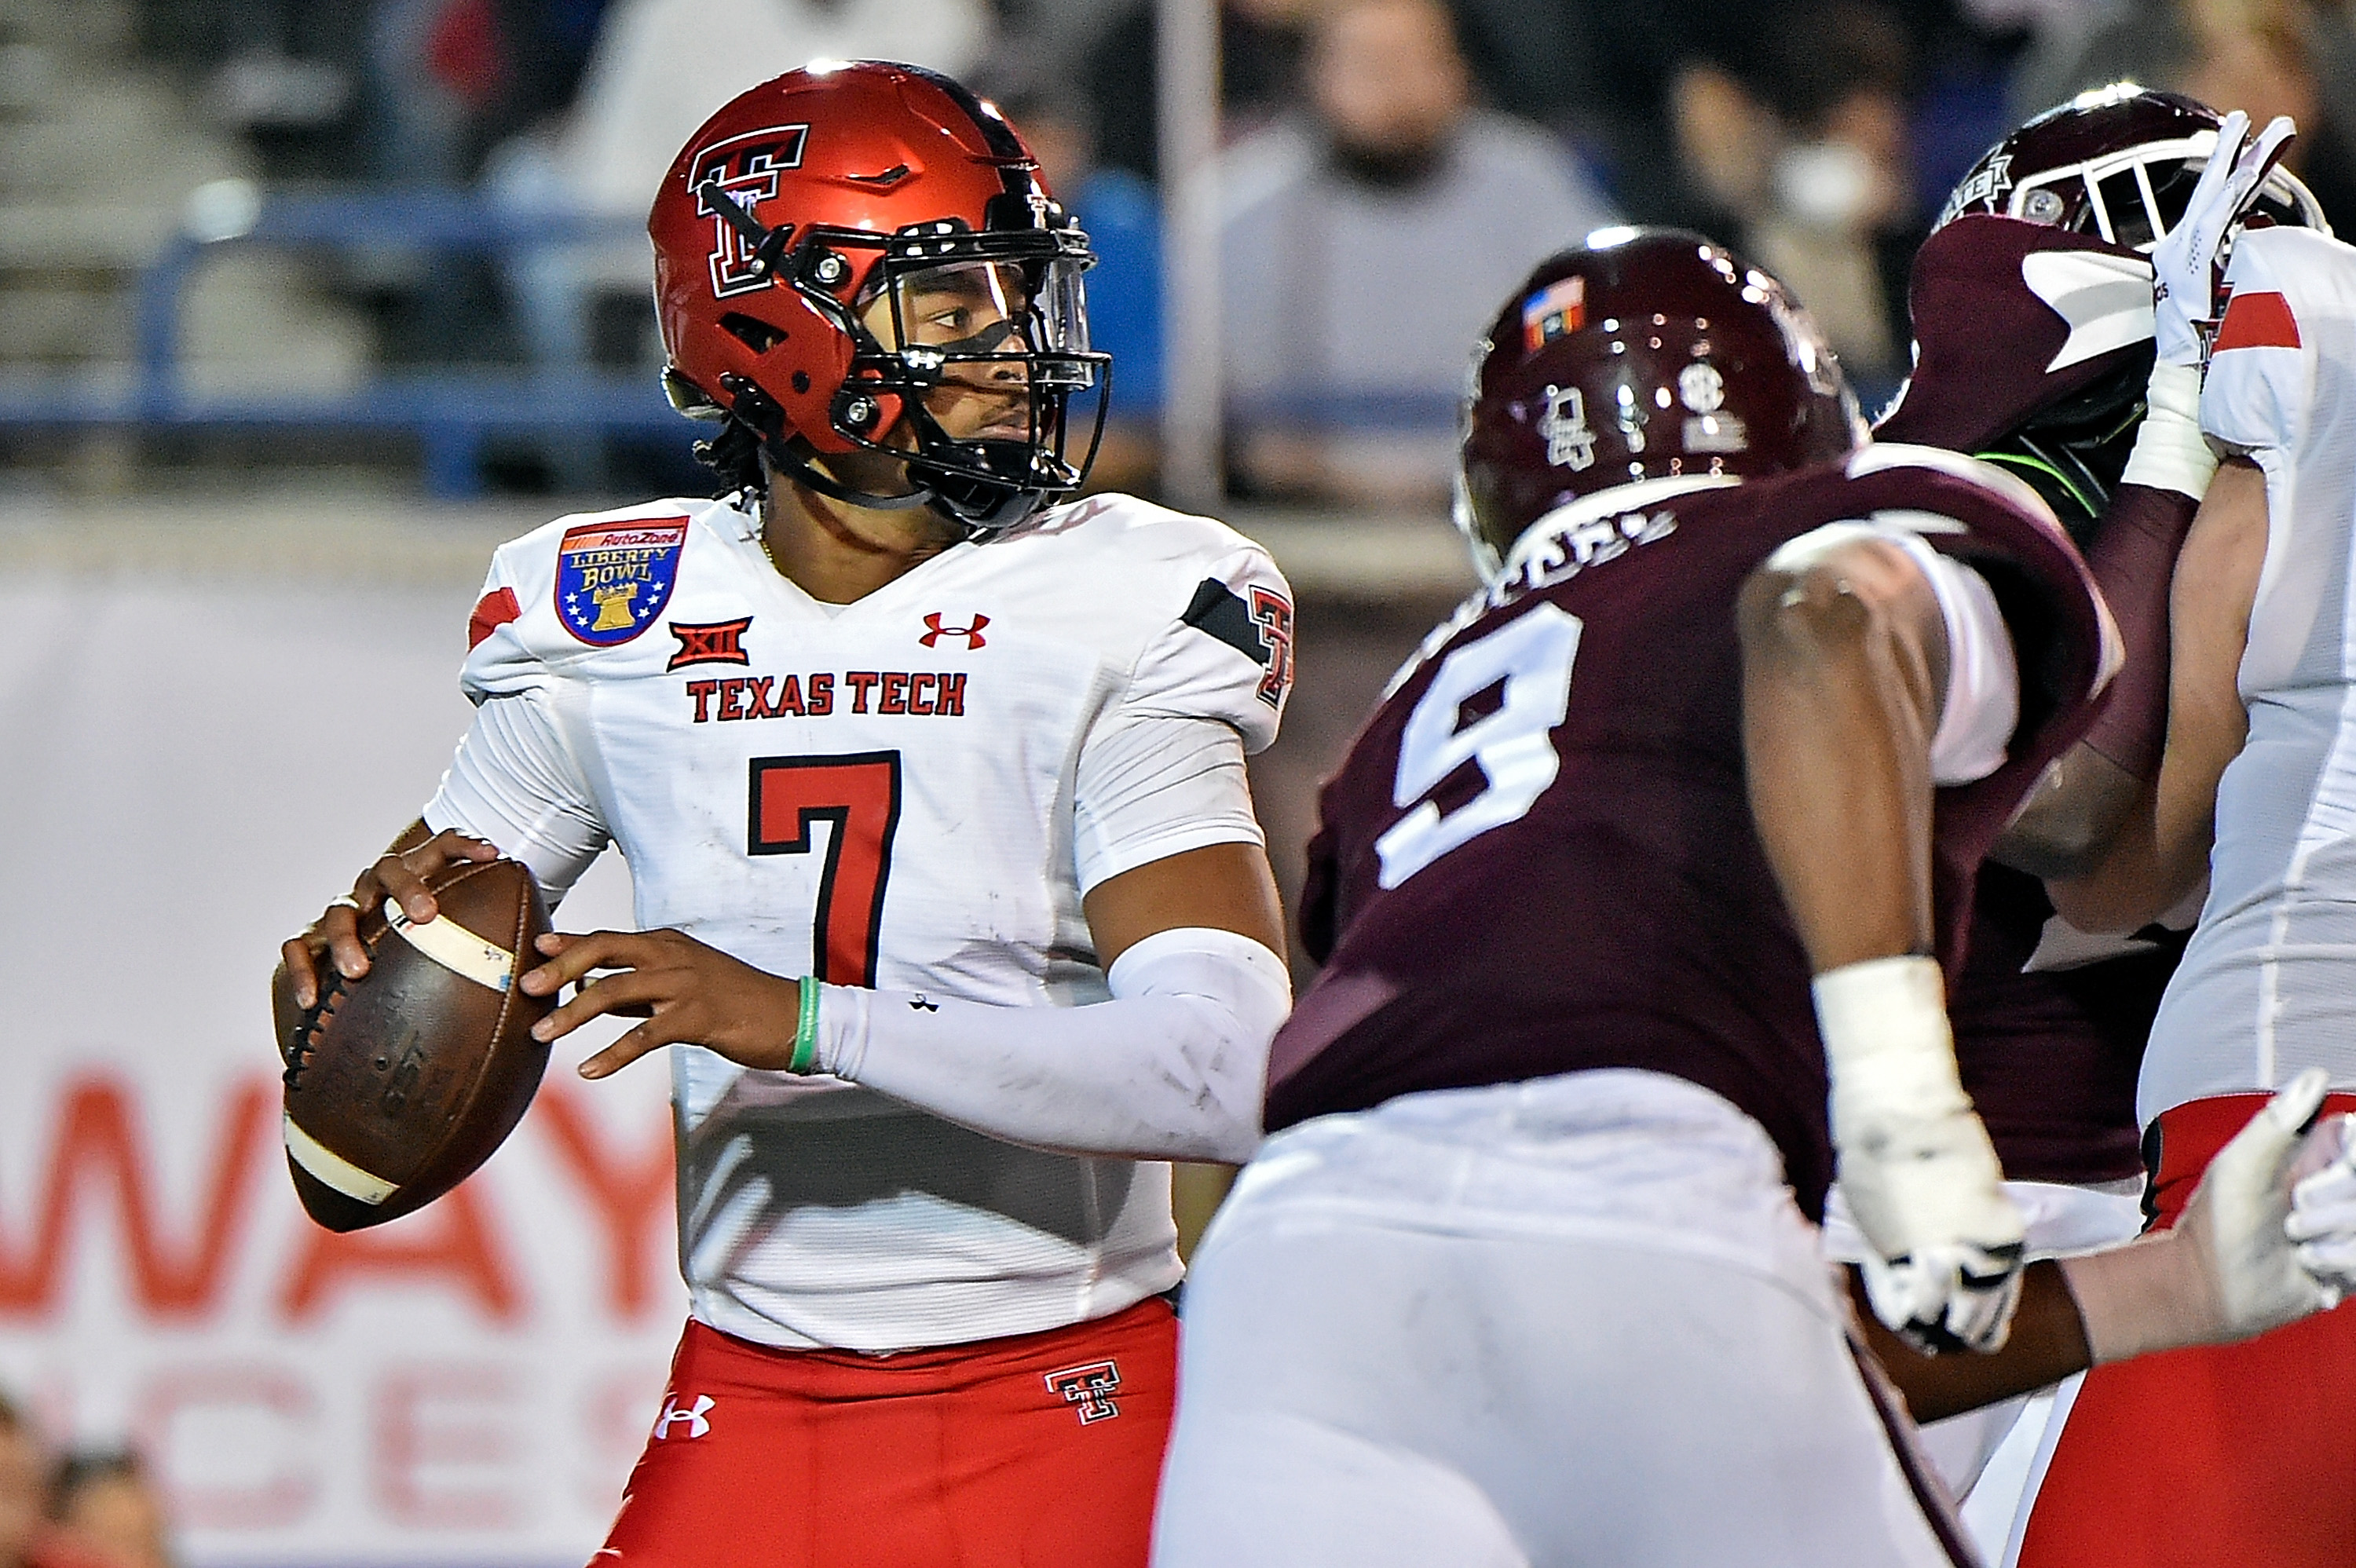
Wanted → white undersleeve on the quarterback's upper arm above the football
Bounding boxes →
[424,690,610,908]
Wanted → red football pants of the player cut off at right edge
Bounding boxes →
[2019,1095,2356,1568]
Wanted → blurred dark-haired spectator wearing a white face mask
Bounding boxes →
[1670,0,1922,405]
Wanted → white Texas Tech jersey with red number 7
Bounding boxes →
[426,497,1291,1351]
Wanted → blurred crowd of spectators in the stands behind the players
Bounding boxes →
[64,0,2356,504]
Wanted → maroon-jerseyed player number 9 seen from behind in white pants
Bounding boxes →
[1154,231,2337,1568]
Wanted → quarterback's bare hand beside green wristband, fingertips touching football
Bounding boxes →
[516,930,801,1078]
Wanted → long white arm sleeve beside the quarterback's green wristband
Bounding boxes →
[815,925,1293,1165]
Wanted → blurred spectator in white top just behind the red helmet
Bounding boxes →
[483,0,992,365]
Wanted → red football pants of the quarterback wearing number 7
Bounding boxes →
[594,1297,1178,1568]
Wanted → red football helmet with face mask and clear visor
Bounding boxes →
[646,61,1110,528]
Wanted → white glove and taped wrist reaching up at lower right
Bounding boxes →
[2062,1066,2356,1363]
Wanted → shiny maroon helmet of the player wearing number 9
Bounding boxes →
[1456,228,1866,575]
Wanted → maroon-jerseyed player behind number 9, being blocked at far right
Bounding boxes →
[1826,82,2321,1514]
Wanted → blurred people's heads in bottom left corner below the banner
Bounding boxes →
[0,1398,172,1568]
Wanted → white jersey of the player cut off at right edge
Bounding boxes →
[2137,228,2356,1123]
